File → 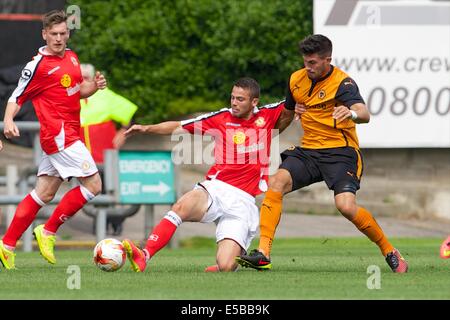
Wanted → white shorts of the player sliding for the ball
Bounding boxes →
[194,179,259,250]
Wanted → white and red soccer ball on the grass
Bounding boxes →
[94,239,126,272]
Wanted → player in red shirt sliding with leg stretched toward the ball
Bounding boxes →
[123,78,294,272]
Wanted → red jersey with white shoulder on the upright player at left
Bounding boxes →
[9,47,83,154]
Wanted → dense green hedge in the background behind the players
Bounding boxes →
[69,0,312,122]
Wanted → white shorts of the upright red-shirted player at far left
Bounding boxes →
[37,140,98,179]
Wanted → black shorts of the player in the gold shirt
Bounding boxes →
[280,147,363,195]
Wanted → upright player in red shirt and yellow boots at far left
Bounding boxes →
[0,10,106,269]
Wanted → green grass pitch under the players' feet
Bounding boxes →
[0,238,450,300]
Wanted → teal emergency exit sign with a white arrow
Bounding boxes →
[118,151,176,204]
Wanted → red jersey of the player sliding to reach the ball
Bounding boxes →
[181,102,284,196]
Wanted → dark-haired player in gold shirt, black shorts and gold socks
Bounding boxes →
[236,34,408,273]
